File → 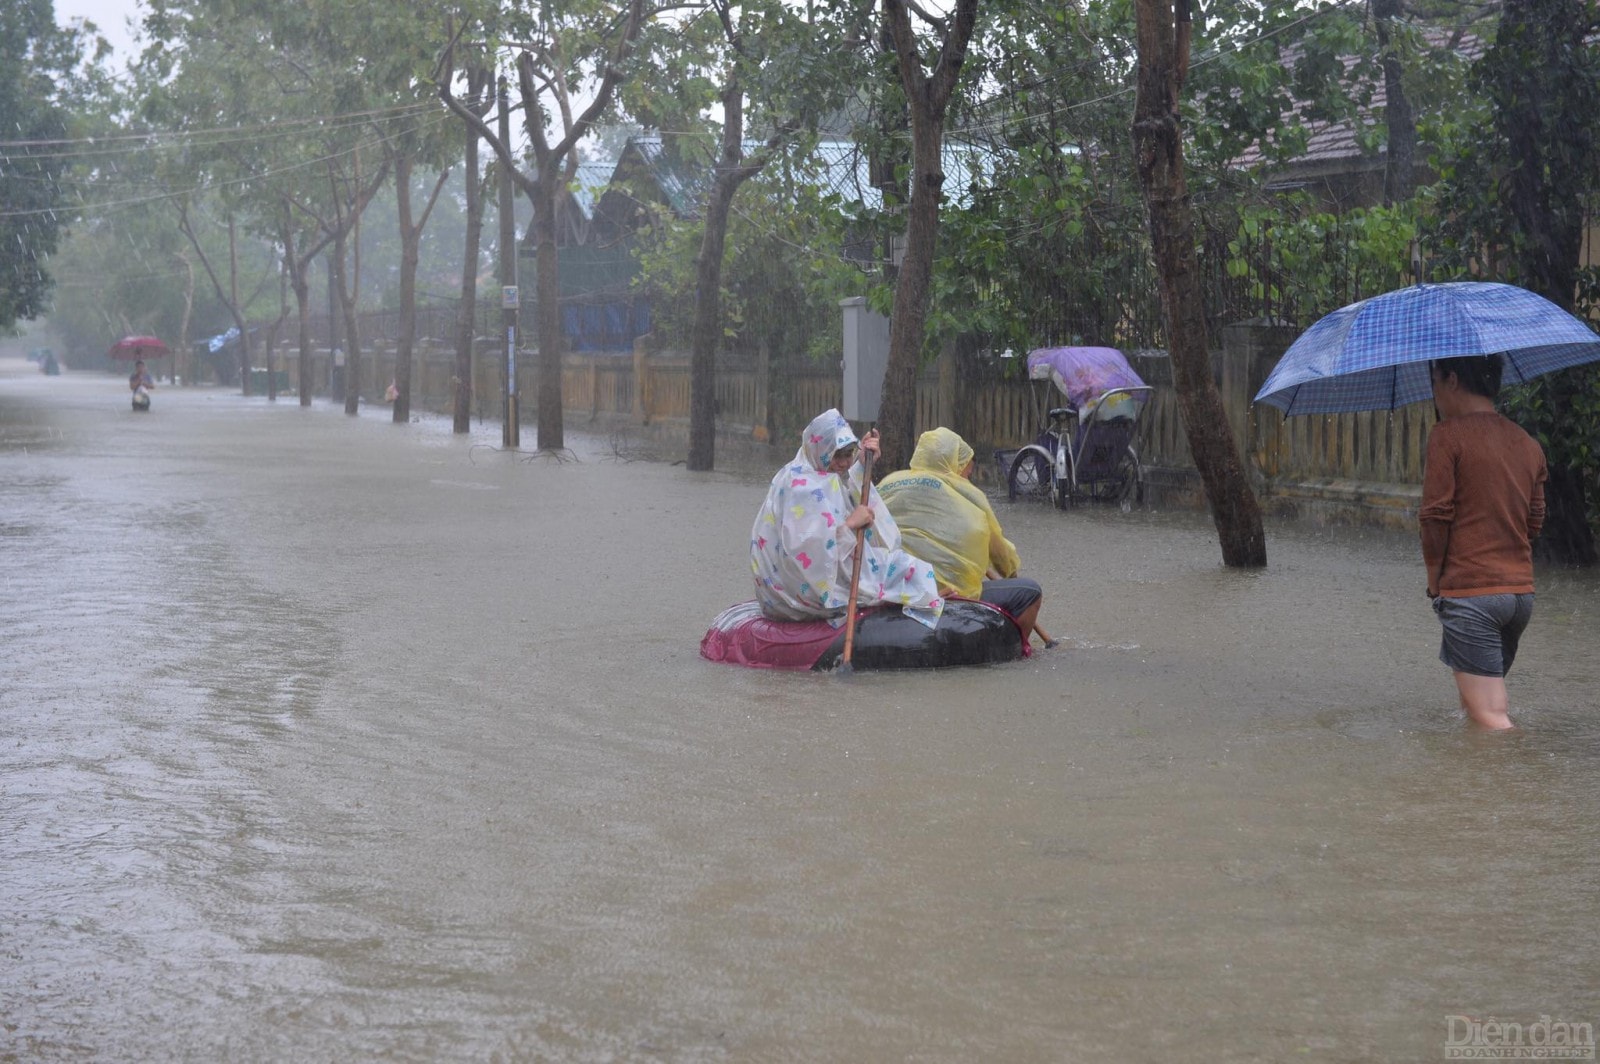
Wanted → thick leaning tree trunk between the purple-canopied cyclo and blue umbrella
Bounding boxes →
[1133,0,1267,568]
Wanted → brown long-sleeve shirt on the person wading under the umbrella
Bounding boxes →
[1418,411,1549,598]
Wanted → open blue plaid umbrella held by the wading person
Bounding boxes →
[1256,282,1600,414]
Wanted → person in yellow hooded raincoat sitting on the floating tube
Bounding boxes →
[878,429,1050,646]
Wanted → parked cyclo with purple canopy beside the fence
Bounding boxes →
[995,347,1155,509]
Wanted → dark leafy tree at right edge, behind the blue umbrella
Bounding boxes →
[1429,0,1600,565]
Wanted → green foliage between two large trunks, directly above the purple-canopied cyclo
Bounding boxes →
[930,3,1158,358]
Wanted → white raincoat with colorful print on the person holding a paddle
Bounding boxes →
[750,410,944,627]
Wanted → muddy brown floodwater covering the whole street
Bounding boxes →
[0,362,1600,1062]
